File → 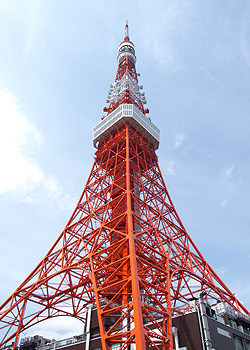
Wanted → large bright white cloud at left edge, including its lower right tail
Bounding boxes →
[0,90,73,208]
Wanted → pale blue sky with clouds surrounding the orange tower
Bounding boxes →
[0,0,250,338]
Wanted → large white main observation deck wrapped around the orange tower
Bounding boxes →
[93,104,160,150]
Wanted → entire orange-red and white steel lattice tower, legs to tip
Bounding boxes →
[0,25,249,350]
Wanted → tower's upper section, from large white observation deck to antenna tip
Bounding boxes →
[93,23,160,149]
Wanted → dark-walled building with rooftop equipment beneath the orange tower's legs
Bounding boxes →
[20,297,250,350]
